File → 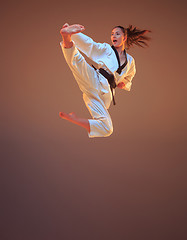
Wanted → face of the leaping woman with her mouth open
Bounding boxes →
[111,28,126,48]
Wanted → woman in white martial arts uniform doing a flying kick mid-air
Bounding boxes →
[59,23,149,137]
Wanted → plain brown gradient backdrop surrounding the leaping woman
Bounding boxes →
[0,0,187,240]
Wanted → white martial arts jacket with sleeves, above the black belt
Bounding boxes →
[72,33,136,91]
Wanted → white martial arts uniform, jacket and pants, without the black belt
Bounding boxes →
[60,33,136,137]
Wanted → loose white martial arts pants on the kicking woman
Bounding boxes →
[61,43,113,137]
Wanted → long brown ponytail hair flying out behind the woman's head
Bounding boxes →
[113,25,151,49]
